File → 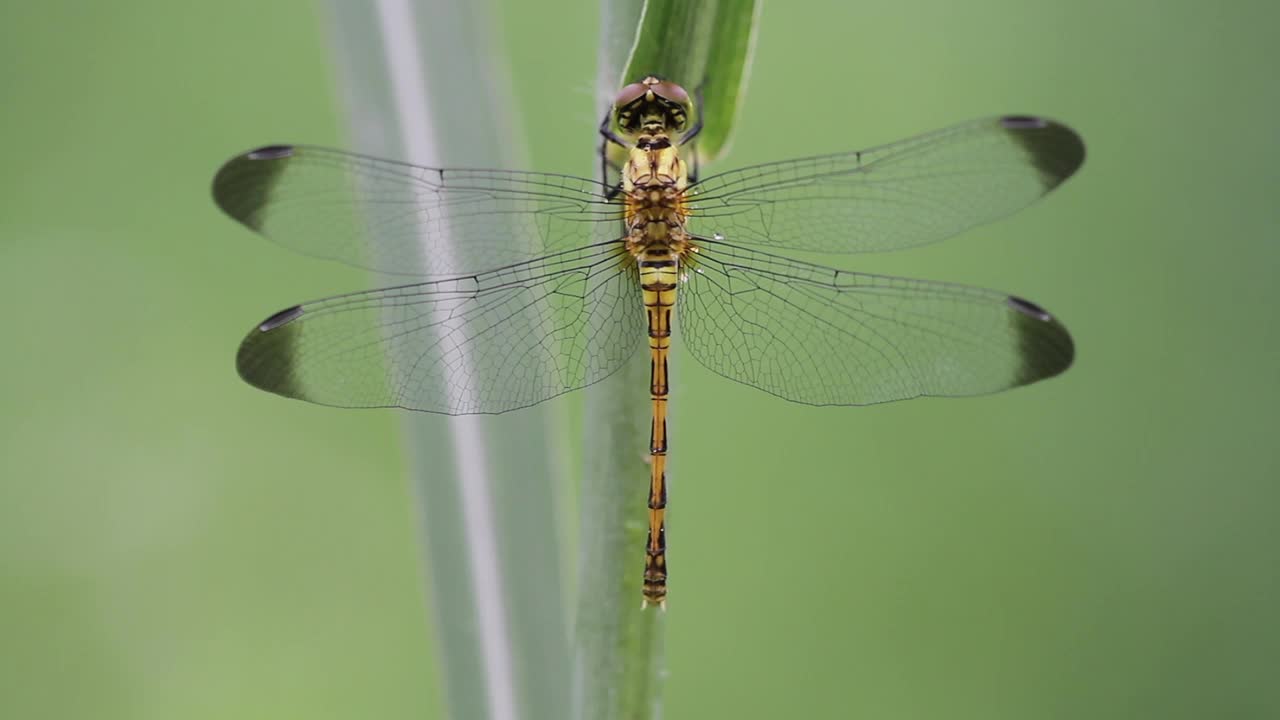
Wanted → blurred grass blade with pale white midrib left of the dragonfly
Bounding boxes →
[332,0,570,720]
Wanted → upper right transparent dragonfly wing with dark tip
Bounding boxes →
[690,117,1084,252]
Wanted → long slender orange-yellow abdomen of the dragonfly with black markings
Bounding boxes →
[639,247,680,606]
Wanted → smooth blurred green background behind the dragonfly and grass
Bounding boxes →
[0,0,1280,720]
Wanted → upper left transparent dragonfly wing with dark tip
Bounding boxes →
[214,145,622,275]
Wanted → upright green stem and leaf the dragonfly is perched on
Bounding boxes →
[573,0,758,720]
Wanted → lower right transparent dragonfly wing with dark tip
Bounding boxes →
[676,240,1074,405]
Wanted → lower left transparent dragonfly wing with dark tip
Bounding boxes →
[236,242,645,415]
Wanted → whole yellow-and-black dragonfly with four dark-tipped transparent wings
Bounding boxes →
[212,77,1084,607]
